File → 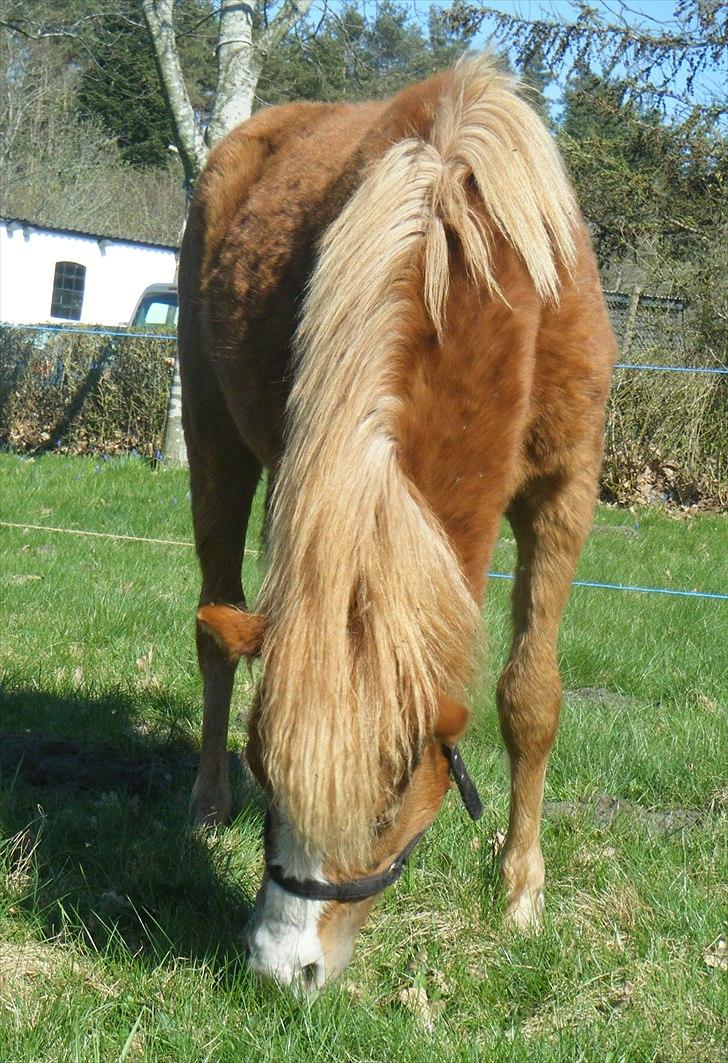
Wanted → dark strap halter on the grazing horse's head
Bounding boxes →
[264,742,482,904]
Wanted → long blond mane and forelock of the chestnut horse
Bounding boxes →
[259,53,575,865]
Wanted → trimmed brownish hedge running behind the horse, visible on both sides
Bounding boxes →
[0,325,728,506]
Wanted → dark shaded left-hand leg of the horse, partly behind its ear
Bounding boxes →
[185,395,260,826]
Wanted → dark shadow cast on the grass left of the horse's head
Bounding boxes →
[0,688,263,971]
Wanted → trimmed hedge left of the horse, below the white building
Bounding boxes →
[0,326,174,458]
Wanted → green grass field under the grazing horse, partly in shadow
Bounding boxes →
[0,455,728,1063]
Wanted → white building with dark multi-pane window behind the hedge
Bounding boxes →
[0,218,177,325]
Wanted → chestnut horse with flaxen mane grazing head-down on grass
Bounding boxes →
[180,58,614,989]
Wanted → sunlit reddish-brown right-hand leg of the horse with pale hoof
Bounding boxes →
[498,455,598,927]
